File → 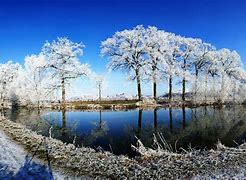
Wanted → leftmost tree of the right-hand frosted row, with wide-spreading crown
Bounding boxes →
[101,26,146,100]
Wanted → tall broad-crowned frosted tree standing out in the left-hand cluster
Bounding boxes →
[42,38,91,104]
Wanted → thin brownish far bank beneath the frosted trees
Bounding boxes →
[2,100,246,111]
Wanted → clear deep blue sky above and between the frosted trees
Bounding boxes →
[0,0,246,97]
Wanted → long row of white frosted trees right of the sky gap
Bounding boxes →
[101,26,246,101]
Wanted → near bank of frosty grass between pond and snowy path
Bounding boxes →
[0,118,246,179]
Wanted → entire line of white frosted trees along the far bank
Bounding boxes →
[0,26,246,107]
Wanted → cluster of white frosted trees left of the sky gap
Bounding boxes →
[0,38,103,107]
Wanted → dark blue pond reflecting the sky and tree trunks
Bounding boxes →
[6,106,246,156]
